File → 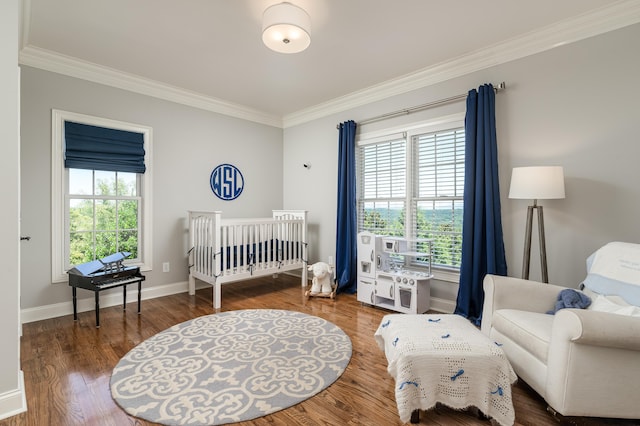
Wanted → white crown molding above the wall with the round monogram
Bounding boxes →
[18,45,282,128]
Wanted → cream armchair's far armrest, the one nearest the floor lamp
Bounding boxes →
[481,274,567,335]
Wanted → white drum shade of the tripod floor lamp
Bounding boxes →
[509,166,564,200]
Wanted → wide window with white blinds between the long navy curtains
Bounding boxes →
[357,114,465,271]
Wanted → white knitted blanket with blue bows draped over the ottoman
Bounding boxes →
[374,314,517,426]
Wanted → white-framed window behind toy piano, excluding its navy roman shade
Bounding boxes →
[52,110,152,282]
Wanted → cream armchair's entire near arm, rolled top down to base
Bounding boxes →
[545,309,640,418]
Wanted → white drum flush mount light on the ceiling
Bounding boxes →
[262,2,311,53]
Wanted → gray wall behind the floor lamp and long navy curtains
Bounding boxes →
[284,25,640,300]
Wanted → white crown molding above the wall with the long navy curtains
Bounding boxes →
[282,0,640,128]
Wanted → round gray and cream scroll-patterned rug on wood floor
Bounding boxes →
[111,309,351,425]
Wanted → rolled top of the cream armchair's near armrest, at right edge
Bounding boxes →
[551,309,640,351]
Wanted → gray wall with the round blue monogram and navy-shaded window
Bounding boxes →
[21,67,283,309]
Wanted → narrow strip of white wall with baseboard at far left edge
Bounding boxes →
[0,0,26,419]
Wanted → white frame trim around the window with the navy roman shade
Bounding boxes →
[51,109,153,283]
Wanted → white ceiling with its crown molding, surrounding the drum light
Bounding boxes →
[20,0,640,124]
